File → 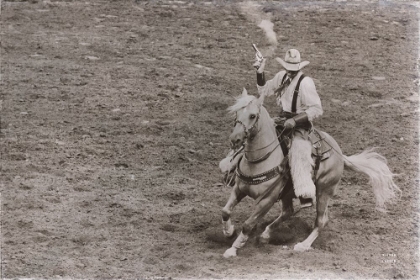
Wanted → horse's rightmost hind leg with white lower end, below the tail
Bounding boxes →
[293,187,335,251]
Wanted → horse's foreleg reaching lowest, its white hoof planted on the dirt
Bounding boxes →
[223,187,279,258]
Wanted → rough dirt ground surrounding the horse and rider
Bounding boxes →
[0,0,419,279]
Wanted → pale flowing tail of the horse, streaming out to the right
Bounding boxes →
[343,148,401,211]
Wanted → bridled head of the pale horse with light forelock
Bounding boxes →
[228,88,265,149]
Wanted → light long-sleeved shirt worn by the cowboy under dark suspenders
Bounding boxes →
[257,71,323,121]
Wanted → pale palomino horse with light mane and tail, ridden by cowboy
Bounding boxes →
[221,89,399,258]
